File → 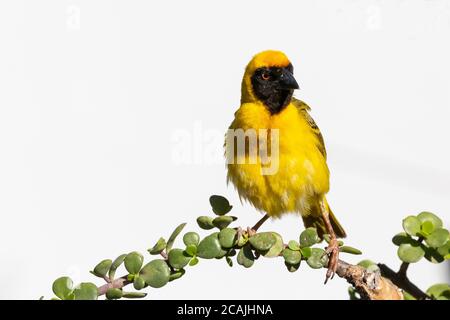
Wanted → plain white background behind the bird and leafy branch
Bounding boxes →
[0,0,450,299]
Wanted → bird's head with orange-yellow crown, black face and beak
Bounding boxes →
[241,50,299,114]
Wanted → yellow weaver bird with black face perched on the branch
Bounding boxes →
[225,50,346,282]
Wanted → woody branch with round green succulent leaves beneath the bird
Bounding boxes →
[47,195,450,300]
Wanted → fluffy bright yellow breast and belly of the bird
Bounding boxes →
[226,103,329,216]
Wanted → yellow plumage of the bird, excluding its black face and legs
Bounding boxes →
[227,51,345,237]
